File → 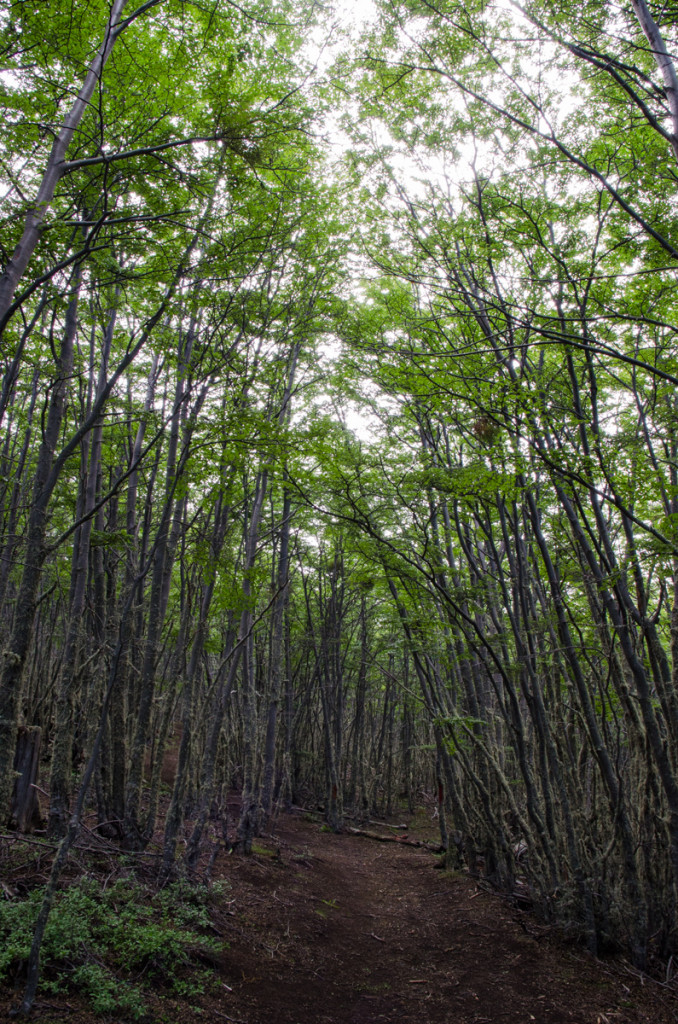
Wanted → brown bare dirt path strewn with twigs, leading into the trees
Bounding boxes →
[0,814,678,1024]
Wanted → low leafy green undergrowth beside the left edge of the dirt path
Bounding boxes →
[0,878,228,1020]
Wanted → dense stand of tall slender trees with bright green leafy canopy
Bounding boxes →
[0,0,678,1008]
